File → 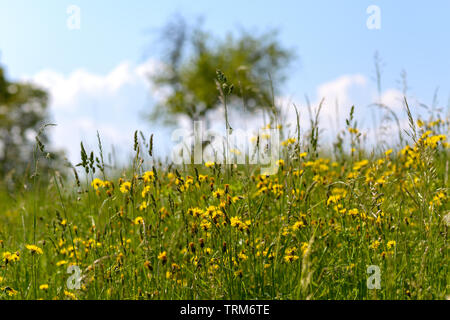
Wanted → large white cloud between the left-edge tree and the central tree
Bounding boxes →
[25,60,172,166]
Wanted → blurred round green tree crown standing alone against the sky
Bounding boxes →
[151,16,293,122]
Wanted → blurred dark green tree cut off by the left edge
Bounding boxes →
[0,67,60,177]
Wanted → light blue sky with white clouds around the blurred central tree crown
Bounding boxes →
[0,0,450,162]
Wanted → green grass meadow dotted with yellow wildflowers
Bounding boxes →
[0,108,450,299]
